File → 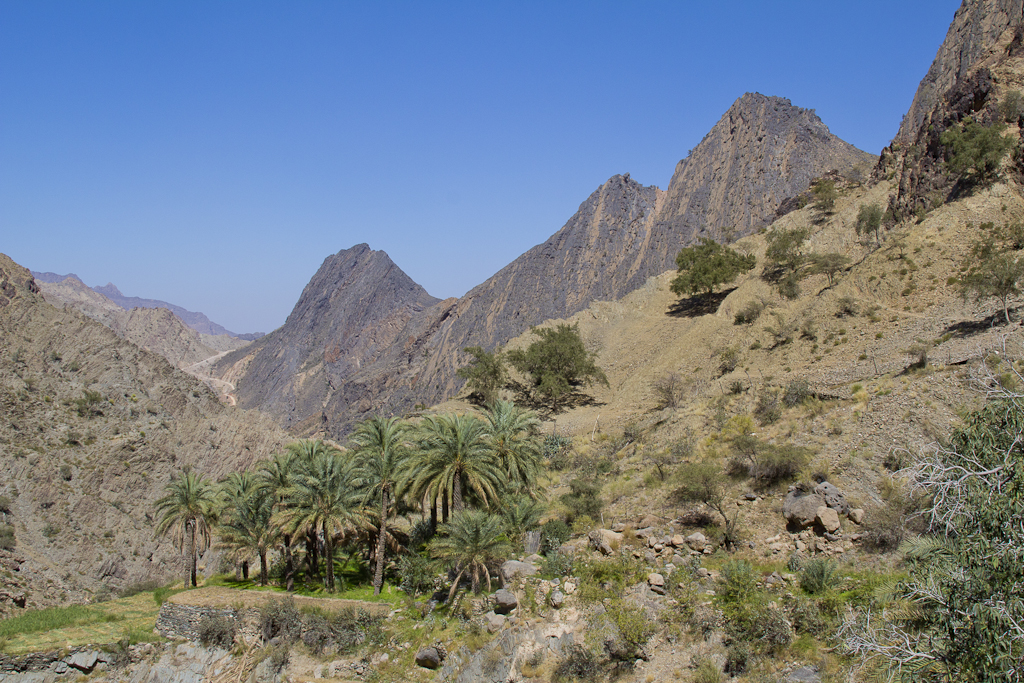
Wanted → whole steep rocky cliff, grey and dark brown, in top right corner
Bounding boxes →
[874,0,1024,219]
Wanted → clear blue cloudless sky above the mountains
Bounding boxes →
[0,0,959,332]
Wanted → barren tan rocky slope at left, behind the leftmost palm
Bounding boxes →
[0,254,288,612]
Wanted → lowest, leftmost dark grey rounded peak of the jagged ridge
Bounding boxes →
[221,244,438,427]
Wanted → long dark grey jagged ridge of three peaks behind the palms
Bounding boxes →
[216,93,874,434]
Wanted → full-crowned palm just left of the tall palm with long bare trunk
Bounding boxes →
[285,446,362,593]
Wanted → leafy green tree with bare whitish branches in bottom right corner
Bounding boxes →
[844,396,1024,683]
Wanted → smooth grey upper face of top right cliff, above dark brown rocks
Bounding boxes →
[894,0,1024,145]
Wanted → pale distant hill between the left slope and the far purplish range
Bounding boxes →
[37,273,249,370]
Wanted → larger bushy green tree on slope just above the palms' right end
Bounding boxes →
[508,323,608,405]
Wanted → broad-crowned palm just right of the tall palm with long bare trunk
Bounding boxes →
[410,415,505,521]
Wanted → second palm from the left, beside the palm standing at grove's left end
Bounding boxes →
[218,472,281,586]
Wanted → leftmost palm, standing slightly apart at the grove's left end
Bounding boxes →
[156,471,216,588]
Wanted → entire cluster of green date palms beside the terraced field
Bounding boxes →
[156,400,542,595]
